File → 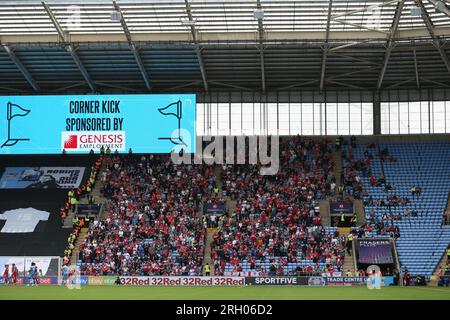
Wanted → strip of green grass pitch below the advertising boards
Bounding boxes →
[0,286,450,300]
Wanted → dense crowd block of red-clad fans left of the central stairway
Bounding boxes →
[79,155,216,275]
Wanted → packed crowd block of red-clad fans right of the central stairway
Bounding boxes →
[211,136,345,275]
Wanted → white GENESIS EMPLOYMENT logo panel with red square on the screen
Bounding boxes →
[61,131,126,152]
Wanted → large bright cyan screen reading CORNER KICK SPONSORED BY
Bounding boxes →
[0,94,196,155]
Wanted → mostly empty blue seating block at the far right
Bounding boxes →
[344,142,450,276]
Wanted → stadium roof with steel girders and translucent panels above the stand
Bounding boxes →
[0,0,450,93]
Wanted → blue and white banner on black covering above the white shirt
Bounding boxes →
[0,167,85,189]
